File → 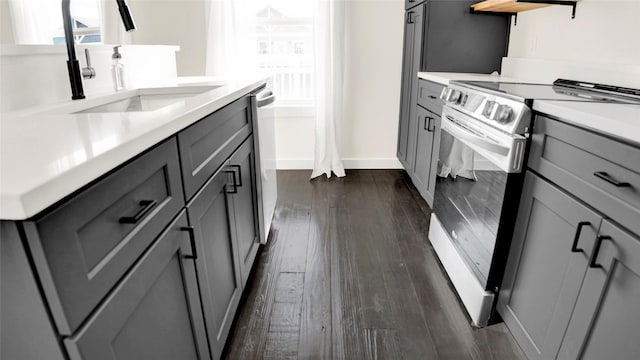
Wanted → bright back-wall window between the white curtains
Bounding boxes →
[254,0,314,106]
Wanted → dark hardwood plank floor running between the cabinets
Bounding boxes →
[226,170,524,359]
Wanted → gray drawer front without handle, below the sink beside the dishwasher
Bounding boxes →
[178,96,251,200]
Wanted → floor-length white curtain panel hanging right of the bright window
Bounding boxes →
[311,0,345,179]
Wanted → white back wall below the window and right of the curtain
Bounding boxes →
[276,0,404,169]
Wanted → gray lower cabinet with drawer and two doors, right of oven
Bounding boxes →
[498,115,640,360]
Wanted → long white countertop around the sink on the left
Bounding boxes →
[0,78,265,220]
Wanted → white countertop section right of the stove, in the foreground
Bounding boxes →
[533,100,640,146]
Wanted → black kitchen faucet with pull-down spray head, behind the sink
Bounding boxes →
[62,0,136,100]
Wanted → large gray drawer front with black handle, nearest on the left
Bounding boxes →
[24,138,184,335]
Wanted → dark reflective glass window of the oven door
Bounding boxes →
[433,131,507,285]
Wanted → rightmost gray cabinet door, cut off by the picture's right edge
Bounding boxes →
[559,220,640,360]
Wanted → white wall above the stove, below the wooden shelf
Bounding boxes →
[503,0,640,87]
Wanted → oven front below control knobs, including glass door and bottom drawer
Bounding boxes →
[429,106,526,326]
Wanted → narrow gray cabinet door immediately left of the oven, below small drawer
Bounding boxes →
[410,106,441,206]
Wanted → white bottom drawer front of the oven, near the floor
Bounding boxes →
[429,214,495,327]
